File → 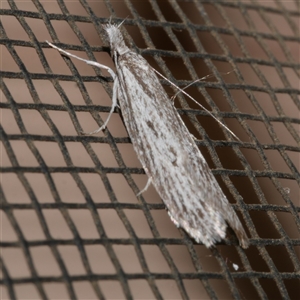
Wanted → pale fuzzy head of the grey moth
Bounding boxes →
[104,24,129,55]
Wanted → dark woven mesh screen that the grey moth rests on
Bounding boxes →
[0,0,300,299]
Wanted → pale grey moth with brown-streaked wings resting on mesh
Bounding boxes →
[47,24,249,248]
